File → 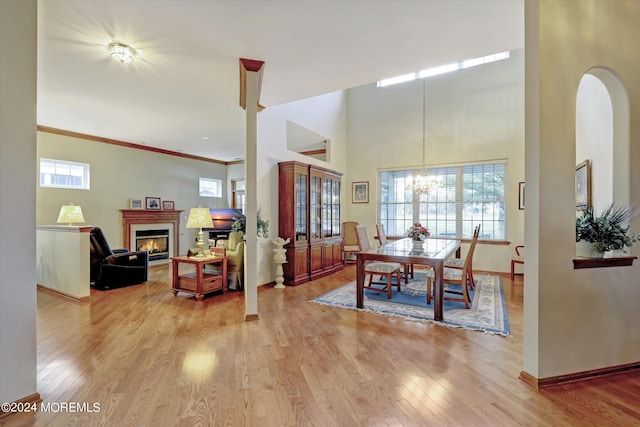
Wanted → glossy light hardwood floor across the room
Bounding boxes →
[0,265,640,427]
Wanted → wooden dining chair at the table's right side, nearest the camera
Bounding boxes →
[427,225,480,309]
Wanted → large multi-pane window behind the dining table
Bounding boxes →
[378,161,507,240]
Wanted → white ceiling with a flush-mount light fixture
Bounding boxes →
[38,0,524,161]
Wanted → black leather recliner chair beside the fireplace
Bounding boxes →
[90,227,149,289]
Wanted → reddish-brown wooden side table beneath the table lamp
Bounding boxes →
[171,256,227,301]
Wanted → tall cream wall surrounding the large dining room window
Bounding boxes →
[342,51,524,271]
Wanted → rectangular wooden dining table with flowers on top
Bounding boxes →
[355,237,460,321]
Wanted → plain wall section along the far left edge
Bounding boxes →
[0,0,37,408]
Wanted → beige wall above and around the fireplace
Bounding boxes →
[36,132,229,254]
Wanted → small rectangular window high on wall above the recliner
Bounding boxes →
[40,158,91,190]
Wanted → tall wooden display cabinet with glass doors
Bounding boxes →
[278,161,343,285]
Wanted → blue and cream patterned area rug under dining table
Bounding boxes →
[311,272,511,337]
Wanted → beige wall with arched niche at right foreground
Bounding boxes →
[524,0,640,378]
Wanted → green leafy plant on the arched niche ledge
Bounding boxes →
[576,203,640,254]
